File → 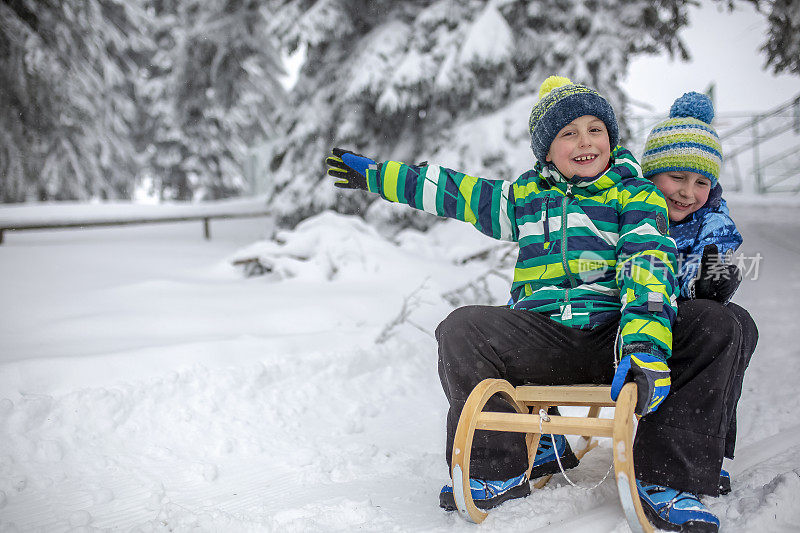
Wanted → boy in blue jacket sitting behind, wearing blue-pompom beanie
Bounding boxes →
[642,92,758,516]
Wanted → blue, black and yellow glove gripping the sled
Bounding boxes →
[611,352,672,416]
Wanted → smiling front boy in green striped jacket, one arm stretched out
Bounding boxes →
[326,76,736,531]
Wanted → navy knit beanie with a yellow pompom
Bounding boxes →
[528,76,619,164]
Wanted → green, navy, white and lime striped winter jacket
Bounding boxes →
[367,146,677,358]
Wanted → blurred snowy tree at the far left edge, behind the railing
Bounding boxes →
[0,0,141,202]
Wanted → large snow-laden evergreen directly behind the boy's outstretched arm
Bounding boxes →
[265,0,689,224]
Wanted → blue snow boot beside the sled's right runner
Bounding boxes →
[636,479,719,533]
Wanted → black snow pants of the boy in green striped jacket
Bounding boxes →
[436,300,758,495]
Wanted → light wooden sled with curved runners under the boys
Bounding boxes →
[450,379,654,533]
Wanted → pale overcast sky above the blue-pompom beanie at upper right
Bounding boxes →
[624,2,800,114]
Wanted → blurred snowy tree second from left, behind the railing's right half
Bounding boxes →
[138,0,285,200]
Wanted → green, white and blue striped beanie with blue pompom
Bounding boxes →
[642,92,722,188]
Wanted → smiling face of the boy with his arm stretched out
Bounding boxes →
[546,115,611,178]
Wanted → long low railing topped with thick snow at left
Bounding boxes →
[0,200,271,244]
